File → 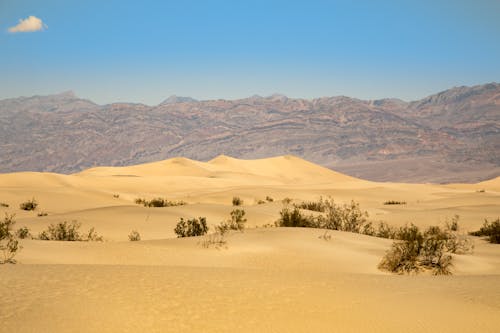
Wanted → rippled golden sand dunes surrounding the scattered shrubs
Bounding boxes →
[0,156,500,332]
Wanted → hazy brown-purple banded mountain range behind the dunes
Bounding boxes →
[0,83,500,183]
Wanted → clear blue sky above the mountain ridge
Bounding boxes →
[0,0,500,105]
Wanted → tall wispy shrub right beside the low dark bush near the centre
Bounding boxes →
[320,199,368,233]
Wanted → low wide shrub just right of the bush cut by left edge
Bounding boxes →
[38,221,103,242]
